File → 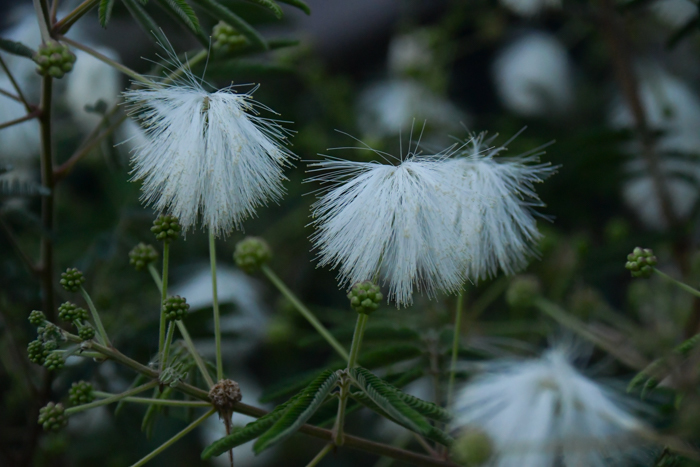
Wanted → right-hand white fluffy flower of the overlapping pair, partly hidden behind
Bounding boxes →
[445,133,556,280]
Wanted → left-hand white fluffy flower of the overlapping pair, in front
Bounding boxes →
[308,136,465,306]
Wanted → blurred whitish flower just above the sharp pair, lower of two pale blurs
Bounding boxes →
[357,79,467,138]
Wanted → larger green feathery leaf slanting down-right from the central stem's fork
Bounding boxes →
[350,367,432,435]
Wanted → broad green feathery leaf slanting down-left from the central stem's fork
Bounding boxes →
[253,370,339,454]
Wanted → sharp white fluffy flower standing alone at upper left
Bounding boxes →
[124,44,294,236]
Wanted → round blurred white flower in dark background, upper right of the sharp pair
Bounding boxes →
[493,31,574,116]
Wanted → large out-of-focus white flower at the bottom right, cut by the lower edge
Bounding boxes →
[454,348,646,467]
